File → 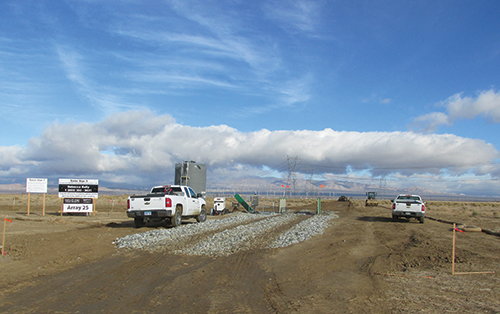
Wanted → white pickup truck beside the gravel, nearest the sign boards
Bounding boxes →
[127,185,207,228]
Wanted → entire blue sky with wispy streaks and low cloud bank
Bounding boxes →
[0,0,500,196]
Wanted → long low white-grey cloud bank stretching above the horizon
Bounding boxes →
[0,111,499,194]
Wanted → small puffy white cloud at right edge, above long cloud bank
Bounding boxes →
[410,89,500,132]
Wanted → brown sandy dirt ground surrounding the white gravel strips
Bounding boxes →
[0,195,500,313]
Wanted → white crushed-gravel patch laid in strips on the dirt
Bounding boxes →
[114,213,338,256]
